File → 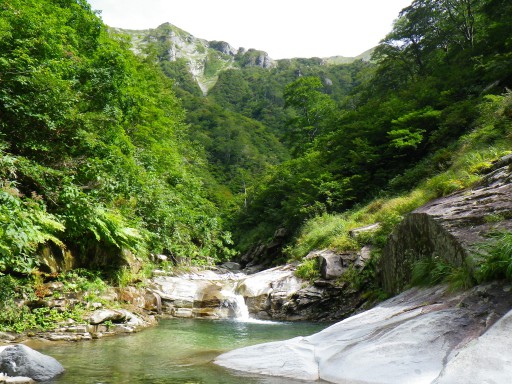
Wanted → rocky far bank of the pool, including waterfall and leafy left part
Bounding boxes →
[0,265,353,343]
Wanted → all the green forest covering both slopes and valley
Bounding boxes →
[0,0,512,330]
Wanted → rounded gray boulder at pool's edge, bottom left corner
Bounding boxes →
[0,344,64,381]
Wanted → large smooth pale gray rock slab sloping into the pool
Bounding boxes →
[215,284,512,384]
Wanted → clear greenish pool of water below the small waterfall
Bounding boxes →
[31,319,326,384]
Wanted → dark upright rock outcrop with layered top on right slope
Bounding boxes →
[381,156,512,292]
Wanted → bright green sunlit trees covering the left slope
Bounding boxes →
[0,0,234,273]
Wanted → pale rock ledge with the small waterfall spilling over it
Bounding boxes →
[150,265,359,321]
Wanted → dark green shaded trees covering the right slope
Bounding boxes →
[231,0,512,255]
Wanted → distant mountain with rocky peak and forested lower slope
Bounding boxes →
[113,23,367,205]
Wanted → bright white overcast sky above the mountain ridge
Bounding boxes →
[89,0,412,59]
